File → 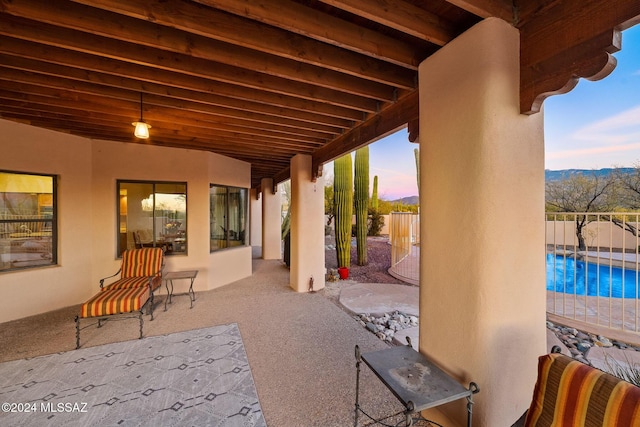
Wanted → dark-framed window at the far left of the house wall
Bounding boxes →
[0,171,58,272]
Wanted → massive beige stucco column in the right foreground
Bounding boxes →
[419,19,546,427]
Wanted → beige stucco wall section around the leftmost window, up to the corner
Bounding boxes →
[0,120,92,322]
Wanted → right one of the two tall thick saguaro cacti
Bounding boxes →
[355,146,369,265]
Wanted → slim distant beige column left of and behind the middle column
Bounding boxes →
[260,178,282,259]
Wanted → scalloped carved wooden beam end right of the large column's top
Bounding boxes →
[520,0,640,114]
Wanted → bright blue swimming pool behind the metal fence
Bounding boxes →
[547,254,640,298]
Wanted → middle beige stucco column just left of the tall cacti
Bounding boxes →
[290,154,325,292]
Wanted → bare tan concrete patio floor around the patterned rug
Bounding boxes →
[0,249,640,427]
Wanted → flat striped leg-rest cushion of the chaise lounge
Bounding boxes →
[80,286,149,317]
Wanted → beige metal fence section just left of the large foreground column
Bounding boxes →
[389,212,420,285]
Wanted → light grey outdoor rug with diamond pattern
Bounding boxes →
[0,324,266,427]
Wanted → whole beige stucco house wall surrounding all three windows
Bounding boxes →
[0,120,251,322]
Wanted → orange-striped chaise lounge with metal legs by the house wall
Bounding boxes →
[75,248,164,348]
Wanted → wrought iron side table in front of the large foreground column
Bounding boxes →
[353,338,480,427]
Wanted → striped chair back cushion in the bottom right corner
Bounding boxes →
[525,353,640,427]
